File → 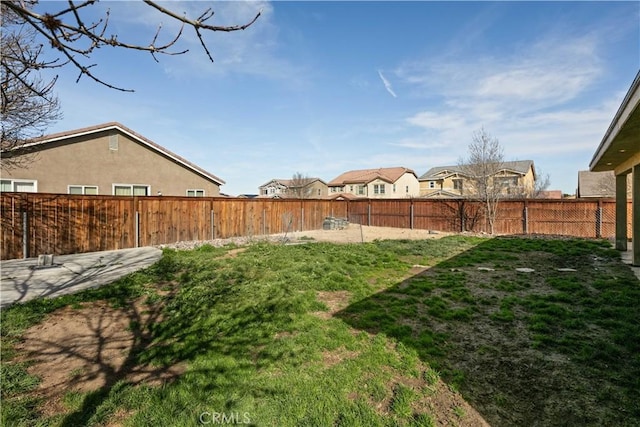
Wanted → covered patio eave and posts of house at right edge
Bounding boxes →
[589,72,640,266]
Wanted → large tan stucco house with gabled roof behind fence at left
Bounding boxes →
[1,122,224,197]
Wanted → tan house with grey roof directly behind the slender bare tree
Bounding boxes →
[418,160,536,198]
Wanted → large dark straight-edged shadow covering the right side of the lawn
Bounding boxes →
[335,236,640,426]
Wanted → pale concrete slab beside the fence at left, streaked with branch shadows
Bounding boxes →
[0,247,162,308]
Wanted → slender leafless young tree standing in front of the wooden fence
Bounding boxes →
[458,128,504,234]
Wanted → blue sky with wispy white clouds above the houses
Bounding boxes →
[38,1,640,195]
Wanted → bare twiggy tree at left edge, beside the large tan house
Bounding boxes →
[0,3,61,169]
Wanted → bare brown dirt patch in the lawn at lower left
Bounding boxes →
[17,299,184,415]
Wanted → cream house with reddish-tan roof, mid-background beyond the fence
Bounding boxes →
[327,166,420,199]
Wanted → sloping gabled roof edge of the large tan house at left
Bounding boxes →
[21,122,225,185]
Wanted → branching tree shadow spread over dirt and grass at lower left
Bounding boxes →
[3,247,296,426]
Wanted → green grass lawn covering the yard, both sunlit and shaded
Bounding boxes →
[1,236,640,426]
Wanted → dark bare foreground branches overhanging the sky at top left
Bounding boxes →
[1,0,261,91]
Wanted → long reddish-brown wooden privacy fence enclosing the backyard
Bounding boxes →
[0,193,631,259]
